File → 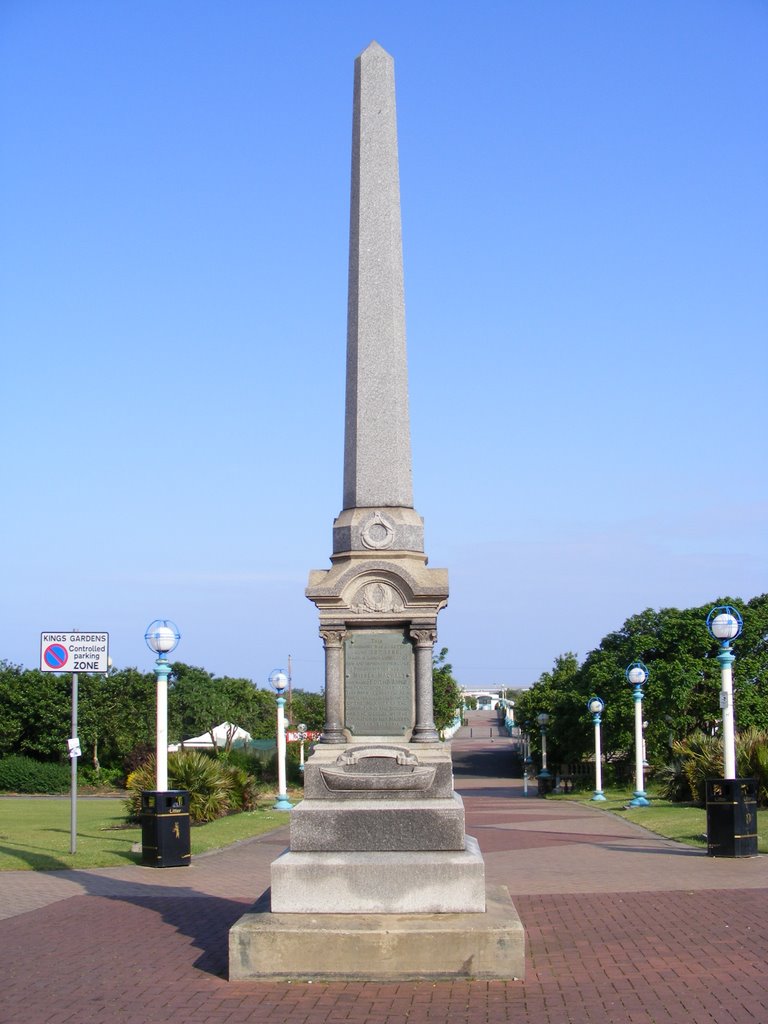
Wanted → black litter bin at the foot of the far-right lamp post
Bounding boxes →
[707,778,758,857]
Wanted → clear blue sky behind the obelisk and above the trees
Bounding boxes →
[0,0,768,689]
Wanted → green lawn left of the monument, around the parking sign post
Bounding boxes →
[0,797,289,871]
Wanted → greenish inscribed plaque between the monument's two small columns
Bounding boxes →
[344,631,414,736]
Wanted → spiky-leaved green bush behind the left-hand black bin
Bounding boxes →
[126,751,255,823]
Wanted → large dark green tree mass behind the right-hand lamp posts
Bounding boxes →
[515,594,768,765]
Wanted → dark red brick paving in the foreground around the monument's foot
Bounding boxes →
[6,891,768,1024]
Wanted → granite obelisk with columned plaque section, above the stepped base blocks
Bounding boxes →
[307,43,447,743]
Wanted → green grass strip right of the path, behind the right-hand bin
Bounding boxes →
[547,788,768,853]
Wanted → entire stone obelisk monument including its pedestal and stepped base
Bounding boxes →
[229,43,524,979]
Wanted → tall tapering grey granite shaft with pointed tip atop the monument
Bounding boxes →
[343,43,414,509]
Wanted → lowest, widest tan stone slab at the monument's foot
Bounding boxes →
[229,886,525,981]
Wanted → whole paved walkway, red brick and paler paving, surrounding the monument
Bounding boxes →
[0,713,768,1024]
